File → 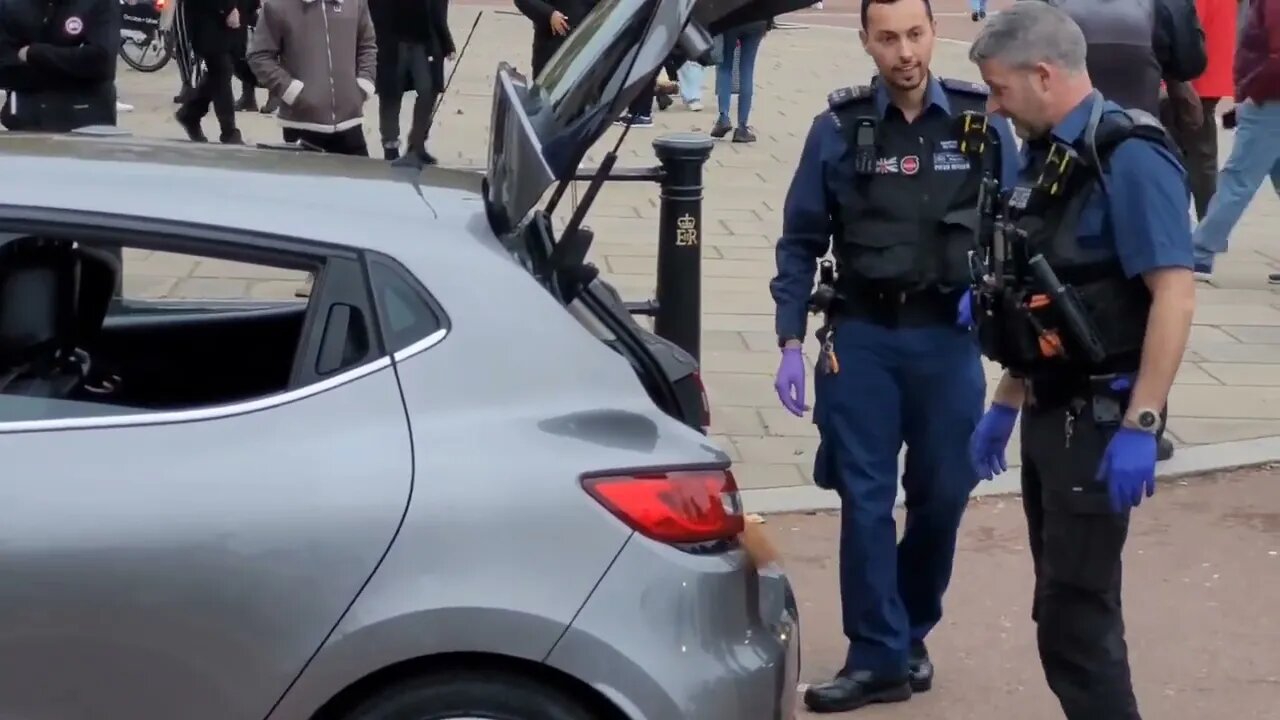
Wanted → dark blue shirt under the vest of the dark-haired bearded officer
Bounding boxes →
[769,76,1018,338]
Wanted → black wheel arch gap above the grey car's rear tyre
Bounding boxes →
[304,651,632,720]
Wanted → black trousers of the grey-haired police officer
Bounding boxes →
[1021,392,1140,720]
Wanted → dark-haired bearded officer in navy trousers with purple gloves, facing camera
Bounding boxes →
[771,0,1016,712]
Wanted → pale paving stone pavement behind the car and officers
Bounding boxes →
[97,0,1280,509]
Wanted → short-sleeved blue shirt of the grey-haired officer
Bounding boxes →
[1023,95,1194,278]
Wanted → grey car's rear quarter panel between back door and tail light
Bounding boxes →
[271,224,728,720]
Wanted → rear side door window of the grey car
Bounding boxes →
[0,227,376,423]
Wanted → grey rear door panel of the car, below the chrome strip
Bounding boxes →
[0,363,412,720]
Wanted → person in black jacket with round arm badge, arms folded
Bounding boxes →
[0,0,120,132]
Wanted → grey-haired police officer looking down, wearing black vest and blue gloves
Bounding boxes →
[969,3,1196,720]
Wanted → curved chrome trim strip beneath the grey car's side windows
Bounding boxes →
[0,328,448,434]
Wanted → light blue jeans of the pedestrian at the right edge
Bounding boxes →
[1192,100,1280,268]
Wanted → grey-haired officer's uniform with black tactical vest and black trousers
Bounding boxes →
[974,95,1192,720]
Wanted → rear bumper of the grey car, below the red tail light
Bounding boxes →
[547,527,800,720]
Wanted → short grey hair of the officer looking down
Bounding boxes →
[969,0,1088,73]
